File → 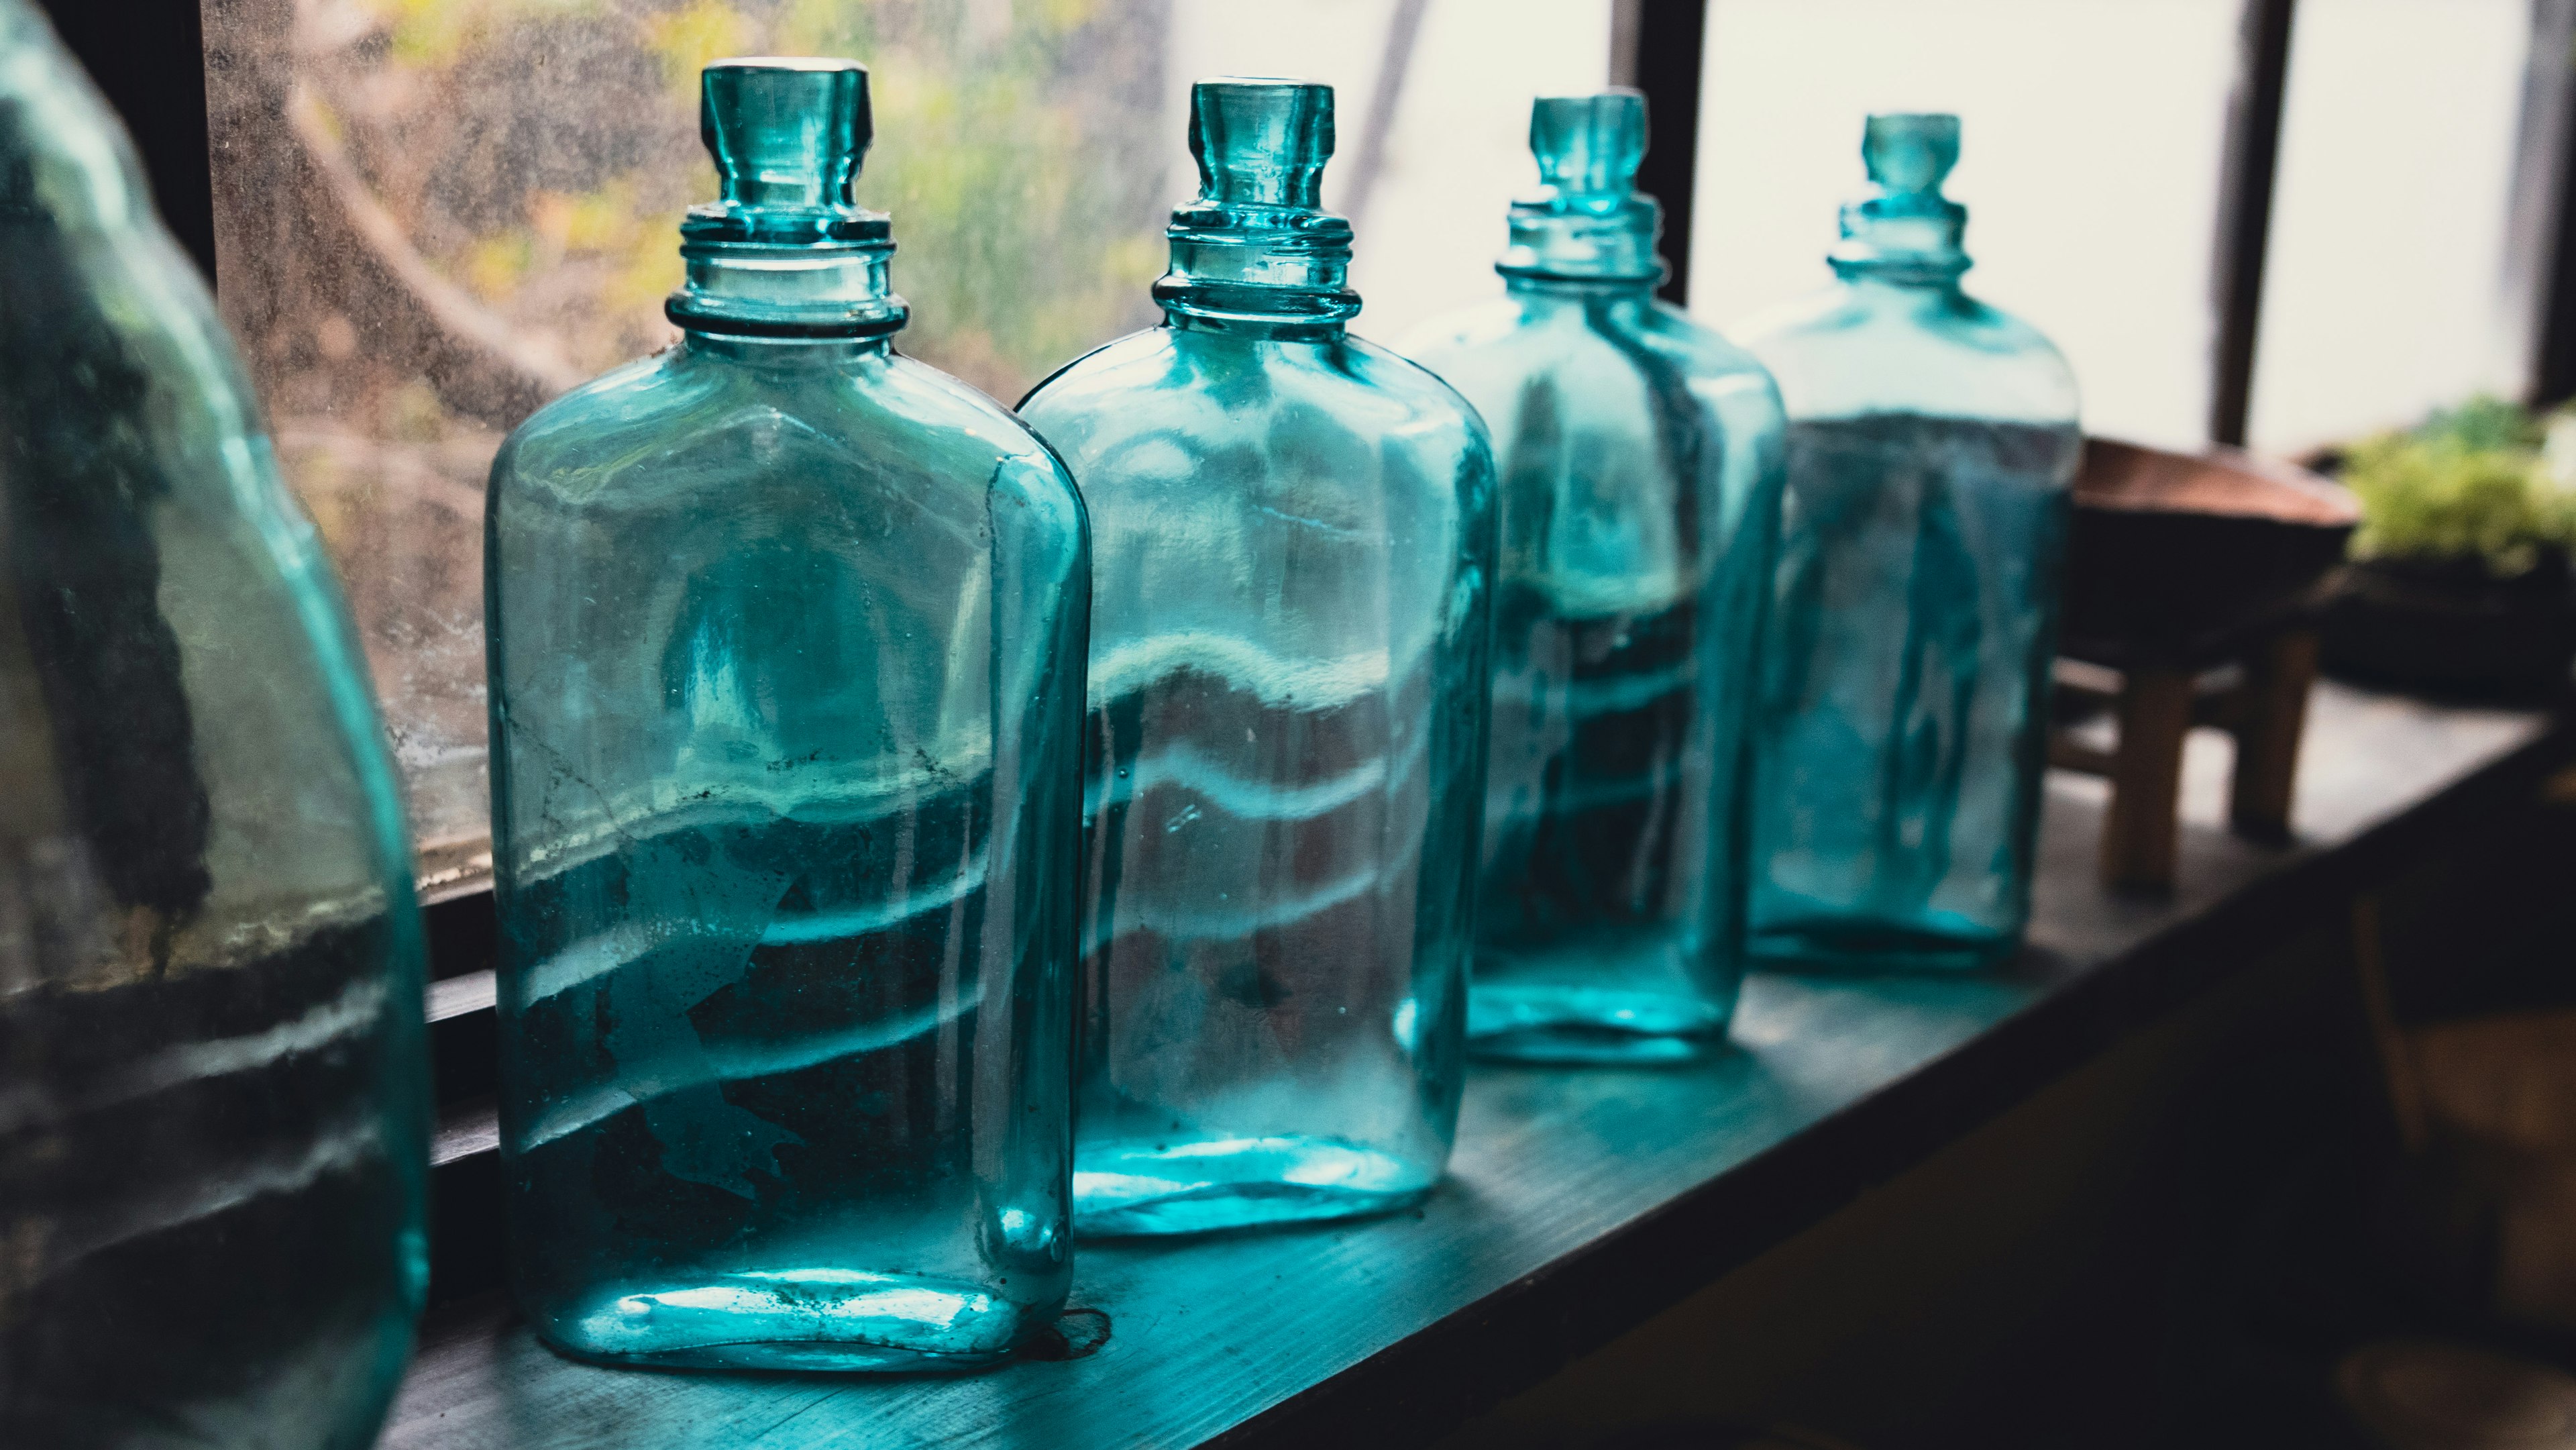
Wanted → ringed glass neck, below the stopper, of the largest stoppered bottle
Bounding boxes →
[662,203,912,340]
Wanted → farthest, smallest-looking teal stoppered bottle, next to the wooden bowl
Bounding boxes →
[1739,116,2082,968]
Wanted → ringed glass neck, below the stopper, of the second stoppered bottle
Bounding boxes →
[1154,199,1360,343]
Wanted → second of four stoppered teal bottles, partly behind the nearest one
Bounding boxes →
[1020,80,1494,1234]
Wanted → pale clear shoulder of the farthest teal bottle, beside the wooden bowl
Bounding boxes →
[1736,283,2079,427]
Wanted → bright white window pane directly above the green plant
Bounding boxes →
[2249,0,2530,451]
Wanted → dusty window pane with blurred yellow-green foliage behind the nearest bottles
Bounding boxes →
[206,0,1607,876]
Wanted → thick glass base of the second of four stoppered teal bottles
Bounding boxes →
[1074,1136,1440,1239]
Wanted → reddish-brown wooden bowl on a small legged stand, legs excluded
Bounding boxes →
[2058,438,2362,667]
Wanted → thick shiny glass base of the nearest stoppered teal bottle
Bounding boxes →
[531,1270,1054,1373]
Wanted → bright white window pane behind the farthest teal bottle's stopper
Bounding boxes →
[1690,0,2239,443]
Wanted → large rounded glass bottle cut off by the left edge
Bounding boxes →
[0,0,430,1450]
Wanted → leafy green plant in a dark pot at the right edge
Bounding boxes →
[2324,397,2576,698]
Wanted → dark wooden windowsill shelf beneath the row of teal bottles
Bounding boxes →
[386,685,2576,1450]
